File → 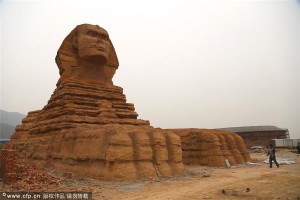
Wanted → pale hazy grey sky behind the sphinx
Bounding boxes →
[0,0,300,138]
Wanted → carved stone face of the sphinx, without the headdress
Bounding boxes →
[73,25,111,65]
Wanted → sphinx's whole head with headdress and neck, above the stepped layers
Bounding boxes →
[55,24,119,84]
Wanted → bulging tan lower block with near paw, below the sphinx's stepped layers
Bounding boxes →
[5,124,184,180]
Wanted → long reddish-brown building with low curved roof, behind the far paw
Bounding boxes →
[218,126,290,148]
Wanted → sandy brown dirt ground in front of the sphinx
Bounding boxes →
[0,149,300,200]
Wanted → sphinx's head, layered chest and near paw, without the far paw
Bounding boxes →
[5,24,184,180]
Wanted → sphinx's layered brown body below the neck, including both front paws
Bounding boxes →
[5,79,250,180]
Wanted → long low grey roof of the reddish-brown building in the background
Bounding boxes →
[217,126,288,133]
